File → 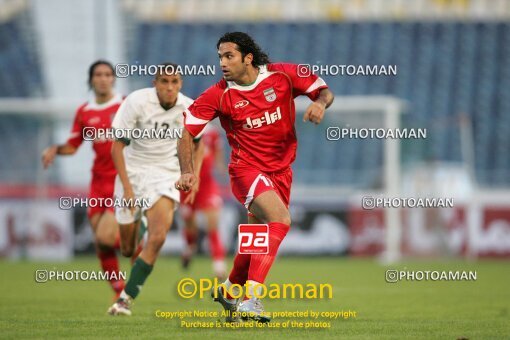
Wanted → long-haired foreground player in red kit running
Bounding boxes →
[176,32,333,322]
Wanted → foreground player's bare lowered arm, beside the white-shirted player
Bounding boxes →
[175,129,197,191]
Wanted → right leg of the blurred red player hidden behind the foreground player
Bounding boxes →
[203,208,226,280]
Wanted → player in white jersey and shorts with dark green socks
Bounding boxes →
[108,63,203,315]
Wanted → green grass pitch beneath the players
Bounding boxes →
[0,257,510,340]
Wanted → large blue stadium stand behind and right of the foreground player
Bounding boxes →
[129,21,510,187]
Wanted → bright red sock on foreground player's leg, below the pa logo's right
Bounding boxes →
[248,222,290,283]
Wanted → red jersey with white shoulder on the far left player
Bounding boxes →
[67,95,123,175]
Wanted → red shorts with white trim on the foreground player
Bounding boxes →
[228,164,292,210]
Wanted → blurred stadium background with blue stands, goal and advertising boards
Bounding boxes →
[0,0,510,260]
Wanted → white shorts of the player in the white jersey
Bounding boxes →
[114,167,180,224]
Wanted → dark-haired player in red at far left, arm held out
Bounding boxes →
[42,60,124,296]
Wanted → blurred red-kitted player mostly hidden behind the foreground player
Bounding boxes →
[180,124,226,280]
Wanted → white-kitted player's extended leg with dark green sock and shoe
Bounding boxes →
[108,197,175,315]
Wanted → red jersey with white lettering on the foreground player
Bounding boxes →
[184,63,327,172]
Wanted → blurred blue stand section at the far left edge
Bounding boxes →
[0,1,45,183]
